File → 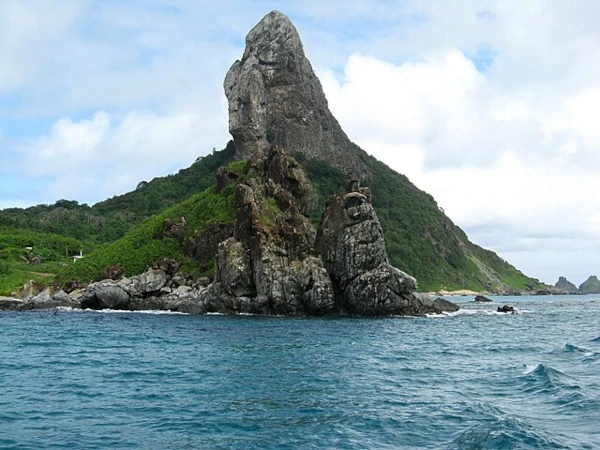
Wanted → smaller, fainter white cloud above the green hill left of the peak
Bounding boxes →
[26,111,226,203]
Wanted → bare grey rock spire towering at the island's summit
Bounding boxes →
[224,11,369,179]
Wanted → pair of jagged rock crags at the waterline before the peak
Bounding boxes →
[197,147,456,315]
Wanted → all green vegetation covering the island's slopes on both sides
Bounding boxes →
[0,142,541,293]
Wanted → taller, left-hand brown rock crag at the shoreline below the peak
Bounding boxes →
[208,147,335,315]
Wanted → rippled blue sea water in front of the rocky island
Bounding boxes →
[0,296,600,449]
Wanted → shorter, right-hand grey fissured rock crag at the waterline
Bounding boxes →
[316,183,447,315]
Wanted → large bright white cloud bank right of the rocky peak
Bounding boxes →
[322,39,600,282]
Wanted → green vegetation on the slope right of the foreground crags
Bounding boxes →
[303,150,540,291]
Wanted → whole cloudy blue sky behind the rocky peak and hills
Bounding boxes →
[0,0,600,285]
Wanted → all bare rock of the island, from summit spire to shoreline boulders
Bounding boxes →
[5,11,458,315]
